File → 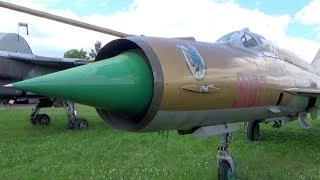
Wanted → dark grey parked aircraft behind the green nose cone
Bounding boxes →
[0,33,89,129]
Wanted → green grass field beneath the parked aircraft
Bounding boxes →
[0,106,320,180]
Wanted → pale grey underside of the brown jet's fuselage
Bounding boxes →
[142,106,287,131]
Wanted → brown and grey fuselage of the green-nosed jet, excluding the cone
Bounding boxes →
[97,32,320,131]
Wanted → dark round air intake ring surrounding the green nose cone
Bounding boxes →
[95,36,164,131]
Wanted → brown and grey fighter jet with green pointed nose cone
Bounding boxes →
[6,1,320,179]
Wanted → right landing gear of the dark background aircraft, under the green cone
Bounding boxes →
[65,102,89,130]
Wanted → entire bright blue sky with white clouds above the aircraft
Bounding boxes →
[0,0,320,62]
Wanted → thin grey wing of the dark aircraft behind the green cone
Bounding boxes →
[0,51,91,68]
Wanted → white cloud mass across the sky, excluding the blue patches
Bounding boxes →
[0,0,320,61]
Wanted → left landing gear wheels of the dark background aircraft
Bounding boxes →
[30,99,53,126]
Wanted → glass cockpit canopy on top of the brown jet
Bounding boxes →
[217,28,277,56]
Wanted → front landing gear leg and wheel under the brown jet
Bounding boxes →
[217,133,236,180]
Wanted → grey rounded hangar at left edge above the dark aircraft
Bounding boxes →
[0,32,33,55]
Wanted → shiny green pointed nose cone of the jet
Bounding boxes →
[12,52,153,115]
